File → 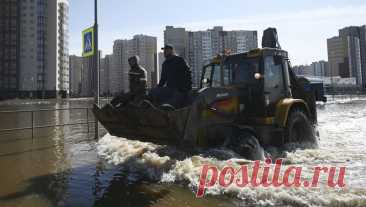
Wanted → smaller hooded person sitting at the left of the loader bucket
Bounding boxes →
[111,55,147,108]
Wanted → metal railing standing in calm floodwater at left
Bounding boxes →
[0,108,97,139]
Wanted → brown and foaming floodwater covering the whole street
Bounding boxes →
[0,98,366,207]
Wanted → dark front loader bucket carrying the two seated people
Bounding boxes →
[93,104,190,145]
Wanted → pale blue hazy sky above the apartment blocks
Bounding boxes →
[69,0,366,65]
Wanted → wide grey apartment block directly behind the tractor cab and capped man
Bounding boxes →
[164,26,258,87]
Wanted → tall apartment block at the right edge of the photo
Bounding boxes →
[327,26,366,87]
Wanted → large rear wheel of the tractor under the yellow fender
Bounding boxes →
[285,109,315,143]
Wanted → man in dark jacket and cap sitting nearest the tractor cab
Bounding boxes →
[152,45,192,108]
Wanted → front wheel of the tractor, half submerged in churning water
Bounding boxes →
[229,131,265,160]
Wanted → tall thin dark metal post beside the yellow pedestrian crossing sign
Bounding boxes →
[94,0,99,139]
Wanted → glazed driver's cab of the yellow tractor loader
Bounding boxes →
[201,48,291,117]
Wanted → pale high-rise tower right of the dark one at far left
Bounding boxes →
[19,0,69,98]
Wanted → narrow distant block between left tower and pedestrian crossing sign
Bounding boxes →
[69,55,83,97]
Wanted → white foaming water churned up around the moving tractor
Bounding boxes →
[98,100,366,206]
